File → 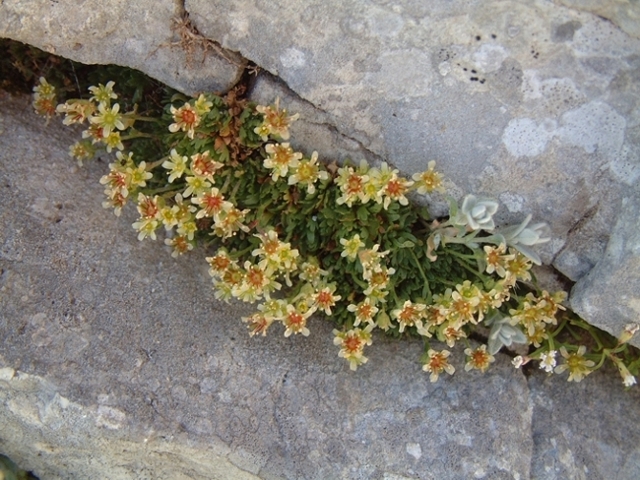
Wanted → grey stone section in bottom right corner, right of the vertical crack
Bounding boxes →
[529,368,640,480]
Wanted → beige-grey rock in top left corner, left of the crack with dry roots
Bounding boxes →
[0,0,244,93]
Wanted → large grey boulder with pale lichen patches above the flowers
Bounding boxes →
[185,0,640,280]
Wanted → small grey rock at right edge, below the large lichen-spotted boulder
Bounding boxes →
[571,192,640,347]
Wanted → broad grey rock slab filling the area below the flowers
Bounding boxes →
[0,90,640,480]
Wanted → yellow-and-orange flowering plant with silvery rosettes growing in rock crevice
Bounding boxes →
[34,79,640,387]
